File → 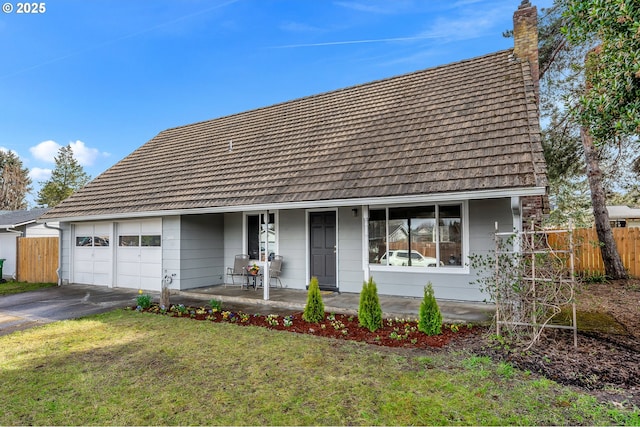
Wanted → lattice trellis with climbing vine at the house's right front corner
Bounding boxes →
[470,223,578,349]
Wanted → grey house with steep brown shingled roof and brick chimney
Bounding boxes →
[40,0,547,301]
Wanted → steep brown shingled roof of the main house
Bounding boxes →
[44,50,547,218]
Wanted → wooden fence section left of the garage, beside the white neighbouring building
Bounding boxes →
[16,237,58,283]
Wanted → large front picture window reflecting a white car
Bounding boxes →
[369,204,462,267]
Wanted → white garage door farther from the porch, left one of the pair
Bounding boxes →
[71,223,112,286]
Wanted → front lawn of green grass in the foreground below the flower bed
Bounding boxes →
[0,310,638,425]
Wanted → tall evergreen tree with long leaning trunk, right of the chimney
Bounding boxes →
[528,0,640,278]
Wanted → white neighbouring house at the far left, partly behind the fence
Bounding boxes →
[0,208,58,279]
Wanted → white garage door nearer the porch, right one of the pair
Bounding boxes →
[116,219,162,291]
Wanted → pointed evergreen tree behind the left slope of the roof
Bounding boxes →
[36,145,91,207]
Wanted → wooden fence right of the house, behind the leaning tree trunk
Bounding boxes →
[549,227,640,277]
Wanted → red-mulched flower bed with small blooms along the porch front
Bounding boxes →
[132,304,482,348]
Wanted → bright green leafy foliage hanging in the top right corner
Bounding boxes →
[563,0,640,140]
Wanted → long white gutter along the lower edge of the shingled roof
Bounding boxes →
[38,187,547,222]
